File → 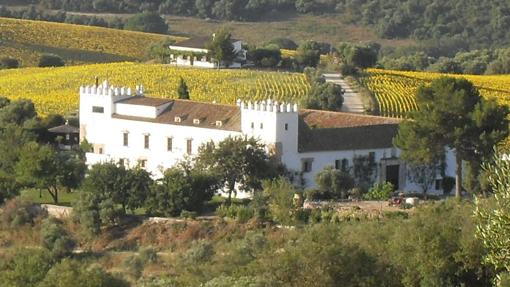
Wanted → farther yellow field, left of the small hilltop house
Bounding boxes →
[0,18,183,66]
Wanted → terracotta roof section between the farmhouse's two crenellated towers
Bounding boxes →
[113,98,241,132]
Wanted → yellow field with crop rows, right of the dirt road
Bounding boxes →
[361,69,510,117]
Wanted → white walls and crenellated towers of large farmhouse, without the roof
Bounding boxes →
[80,83,455,196]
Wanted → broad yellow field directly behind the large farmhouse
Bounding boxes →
[0,62,309,115]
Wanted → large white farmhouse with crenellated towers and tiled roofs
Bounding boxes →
[80,81,455,197]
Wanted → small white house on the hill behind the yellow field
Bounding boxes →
[169,34,246,68]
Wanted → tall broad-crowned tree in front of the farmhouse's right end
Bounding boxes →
[395,77,508,196]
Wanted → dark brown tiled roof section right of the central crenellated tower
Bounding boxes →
[298,110,401,152]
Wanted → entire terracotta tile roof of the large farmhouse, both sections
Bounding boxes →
[113,97,401,152]
